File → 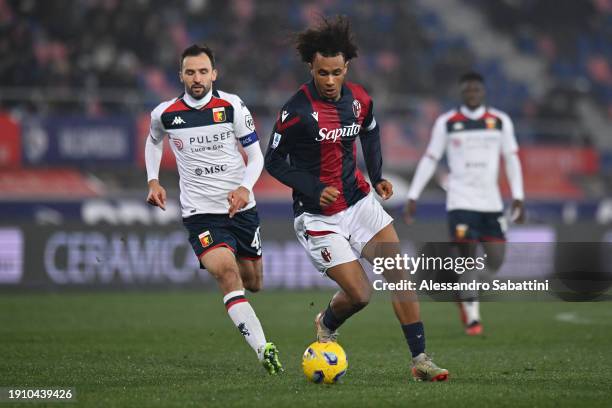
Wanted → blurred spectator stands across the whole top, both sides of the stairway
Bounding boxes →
[0,0,612,135]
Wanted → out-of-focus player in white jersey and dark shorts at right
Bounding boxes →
[404,72,525,335]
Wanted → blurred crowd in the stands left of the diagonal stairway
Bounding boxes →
[0,0,472,112]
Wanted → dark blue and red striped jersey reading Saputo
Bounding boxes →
[266,81,382,216]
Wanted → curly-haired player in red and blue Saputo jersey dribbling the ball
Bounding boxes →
[266,17,448,381]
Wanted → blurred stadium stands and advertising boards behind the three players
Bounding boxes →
[0,0,612,288]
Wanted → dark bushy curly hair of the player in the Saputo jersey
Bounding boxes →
[295,16,357,63]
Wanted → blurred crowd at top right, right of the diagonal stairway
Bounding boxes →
[474,0,612,118]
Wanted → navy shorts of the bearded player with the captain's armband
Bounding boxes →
[183,207,261,266]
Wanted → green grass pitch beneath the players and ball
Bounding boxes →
[0,292,612,407]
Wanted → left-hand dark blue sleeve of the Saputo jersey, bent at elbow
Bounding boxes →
[265,110,326,198]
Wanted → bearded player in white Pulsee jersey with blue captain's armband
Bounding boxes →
[145,45,282,374]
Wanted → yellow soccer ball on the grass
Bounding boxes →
[302,341,348,384]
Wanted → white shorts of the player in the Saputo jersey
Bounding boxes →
[293,192,393,273]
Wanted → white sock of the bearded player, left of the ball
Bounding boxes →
[223,289,266,360]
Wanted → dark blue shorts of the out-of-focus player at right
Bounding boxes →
[448,210,506,242]
